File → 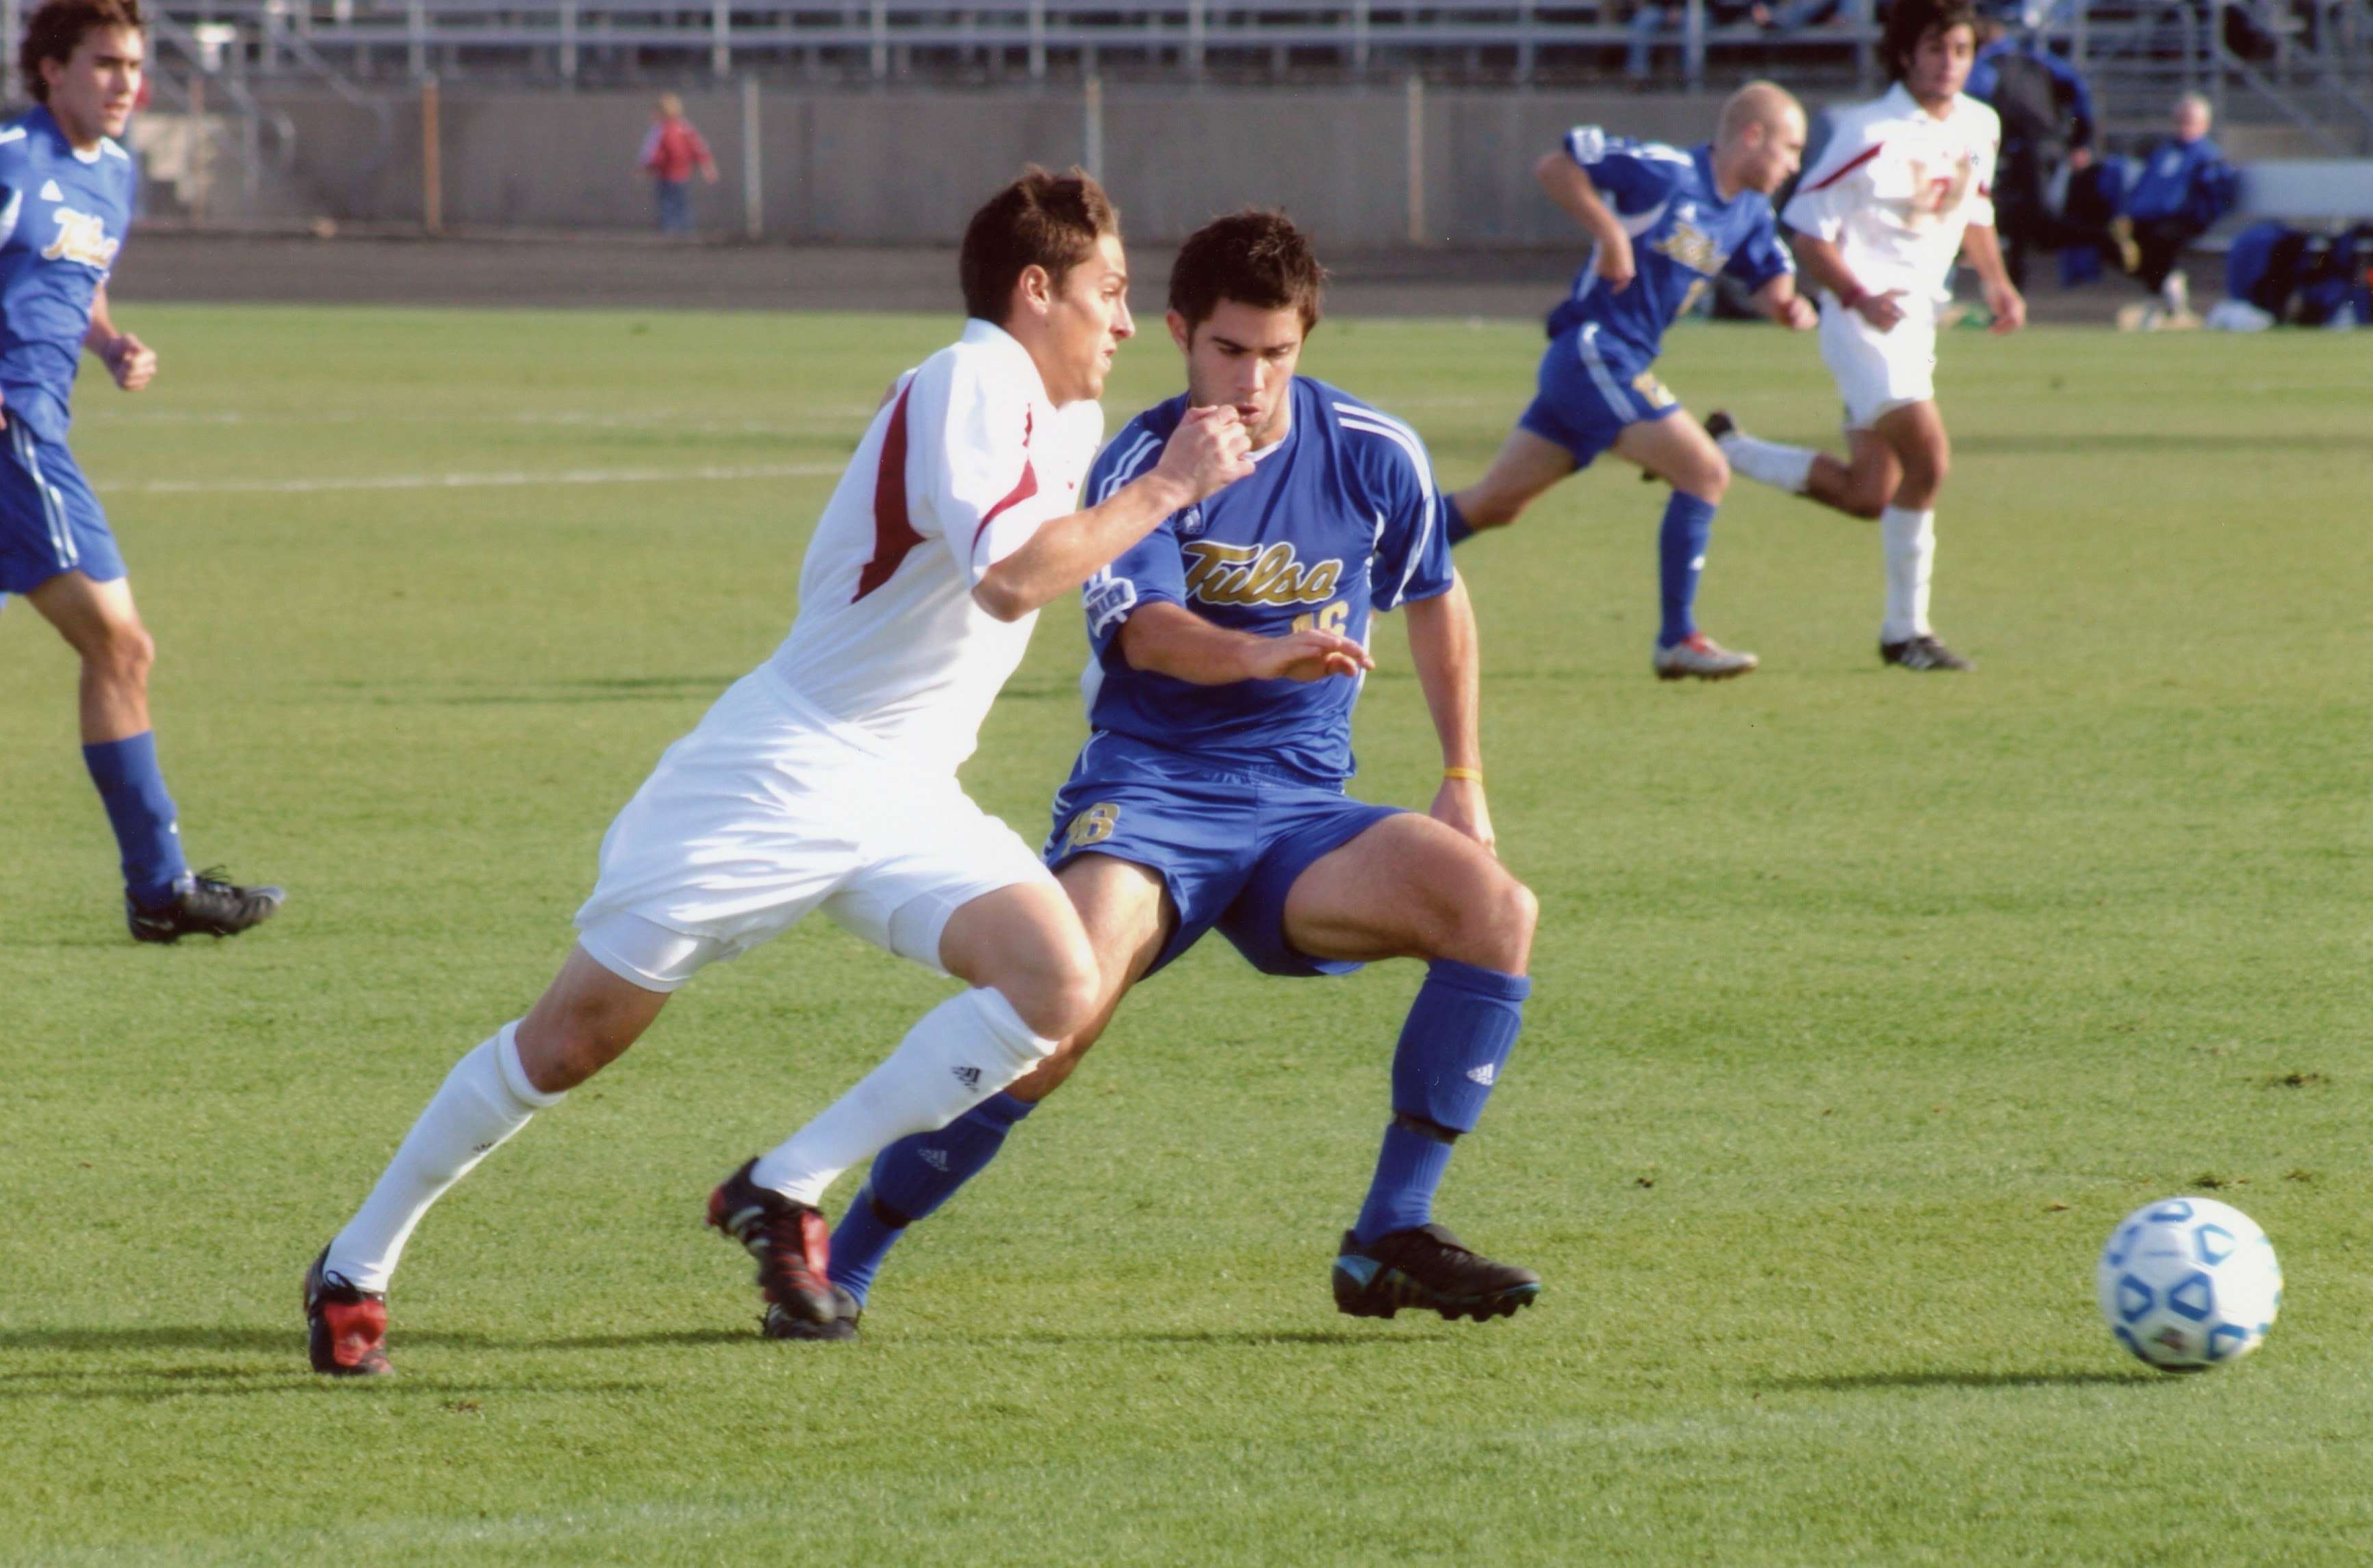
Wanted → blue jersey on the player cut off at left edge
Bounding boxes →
[0,109,136,441]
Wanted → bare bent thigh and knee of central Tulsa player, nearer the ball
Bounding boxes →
[1286,811,1538,975]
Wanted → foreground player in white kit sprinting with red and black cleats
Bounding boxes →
[306,168,1253,1376]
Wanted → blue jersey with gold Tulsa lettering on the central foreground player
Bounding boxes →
[1082,377,1452,783]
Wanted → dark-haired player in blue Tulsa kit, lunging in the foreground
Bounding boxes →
[806,211,1540,1333]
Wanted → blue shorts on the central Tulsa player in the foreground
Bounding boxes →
[1047,733,1400,975]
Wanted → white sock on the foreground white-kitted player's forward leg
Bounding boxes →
[750,987,1056,1203]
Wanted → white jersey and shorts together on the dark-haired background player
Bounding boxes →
[1780,83,2003,429]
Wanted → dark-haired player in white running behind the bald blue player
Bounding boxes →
[1706,0,2027,669]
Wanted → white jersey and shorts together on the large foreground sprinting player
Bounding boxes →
[576,320,1103,992]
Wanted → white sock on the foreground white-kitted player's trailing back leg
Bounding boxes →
[323,1023,563,1290]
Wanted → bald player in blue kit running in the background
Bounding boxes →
[1448,83,1818,681]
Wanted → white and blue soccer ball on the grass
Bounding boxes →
[2095,1198,2283,1371]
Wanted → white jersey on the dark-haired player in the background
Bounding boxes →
[1780,83,2003,304]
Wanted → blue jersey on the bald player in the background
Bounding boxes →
[1550,126,1797,370]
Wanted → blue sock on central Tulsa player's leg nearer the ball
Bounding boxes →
[1352,958,1533,1246]
